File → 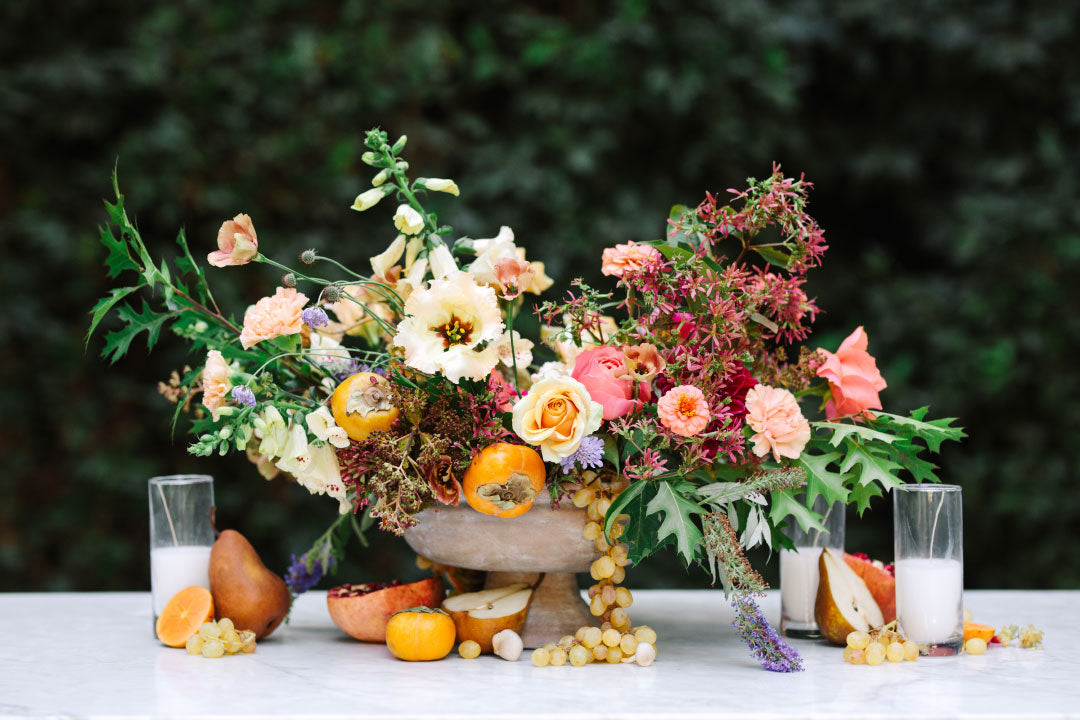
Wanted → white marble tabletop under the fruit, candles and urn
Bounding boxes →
[0,590,1080,720]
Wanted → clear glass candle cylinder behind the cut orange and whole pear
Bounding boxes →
[148,475,214,623]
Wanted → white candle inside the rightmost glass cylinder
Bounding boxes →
[896,558,963,643]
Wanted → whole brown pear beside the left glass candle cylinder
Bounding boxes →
[210,530,292,640]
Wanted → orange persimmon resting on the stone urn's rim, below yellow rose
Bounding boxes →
[463,443,548,517]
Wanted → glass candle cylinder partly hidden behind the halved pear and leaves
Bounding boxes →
[780,495,846,638]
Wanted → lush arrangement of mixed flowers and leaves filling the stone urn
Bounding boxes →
[87,130,963,670]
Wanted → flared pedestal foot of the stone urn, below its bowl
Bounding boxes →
[484,572,595,648]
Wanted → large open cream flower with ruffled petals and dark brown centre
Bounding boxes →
[394,270,504,383]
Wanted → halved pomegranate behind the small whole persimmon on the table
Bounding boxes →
[326,578,445,642]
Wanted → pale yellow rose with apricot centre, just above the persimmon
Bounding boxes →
[513,376,604,462]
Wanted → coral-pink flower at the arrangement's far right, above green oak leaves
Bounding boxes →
[818,325,888,420]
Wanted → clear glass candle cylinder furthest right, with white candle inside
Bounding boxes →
[892,484,963,655]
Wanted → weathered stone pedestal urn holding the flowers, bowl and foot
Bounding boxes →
[405,491,597,648]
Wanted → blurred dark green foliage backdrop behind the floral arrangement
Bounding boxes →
[0,0,1080,590]
